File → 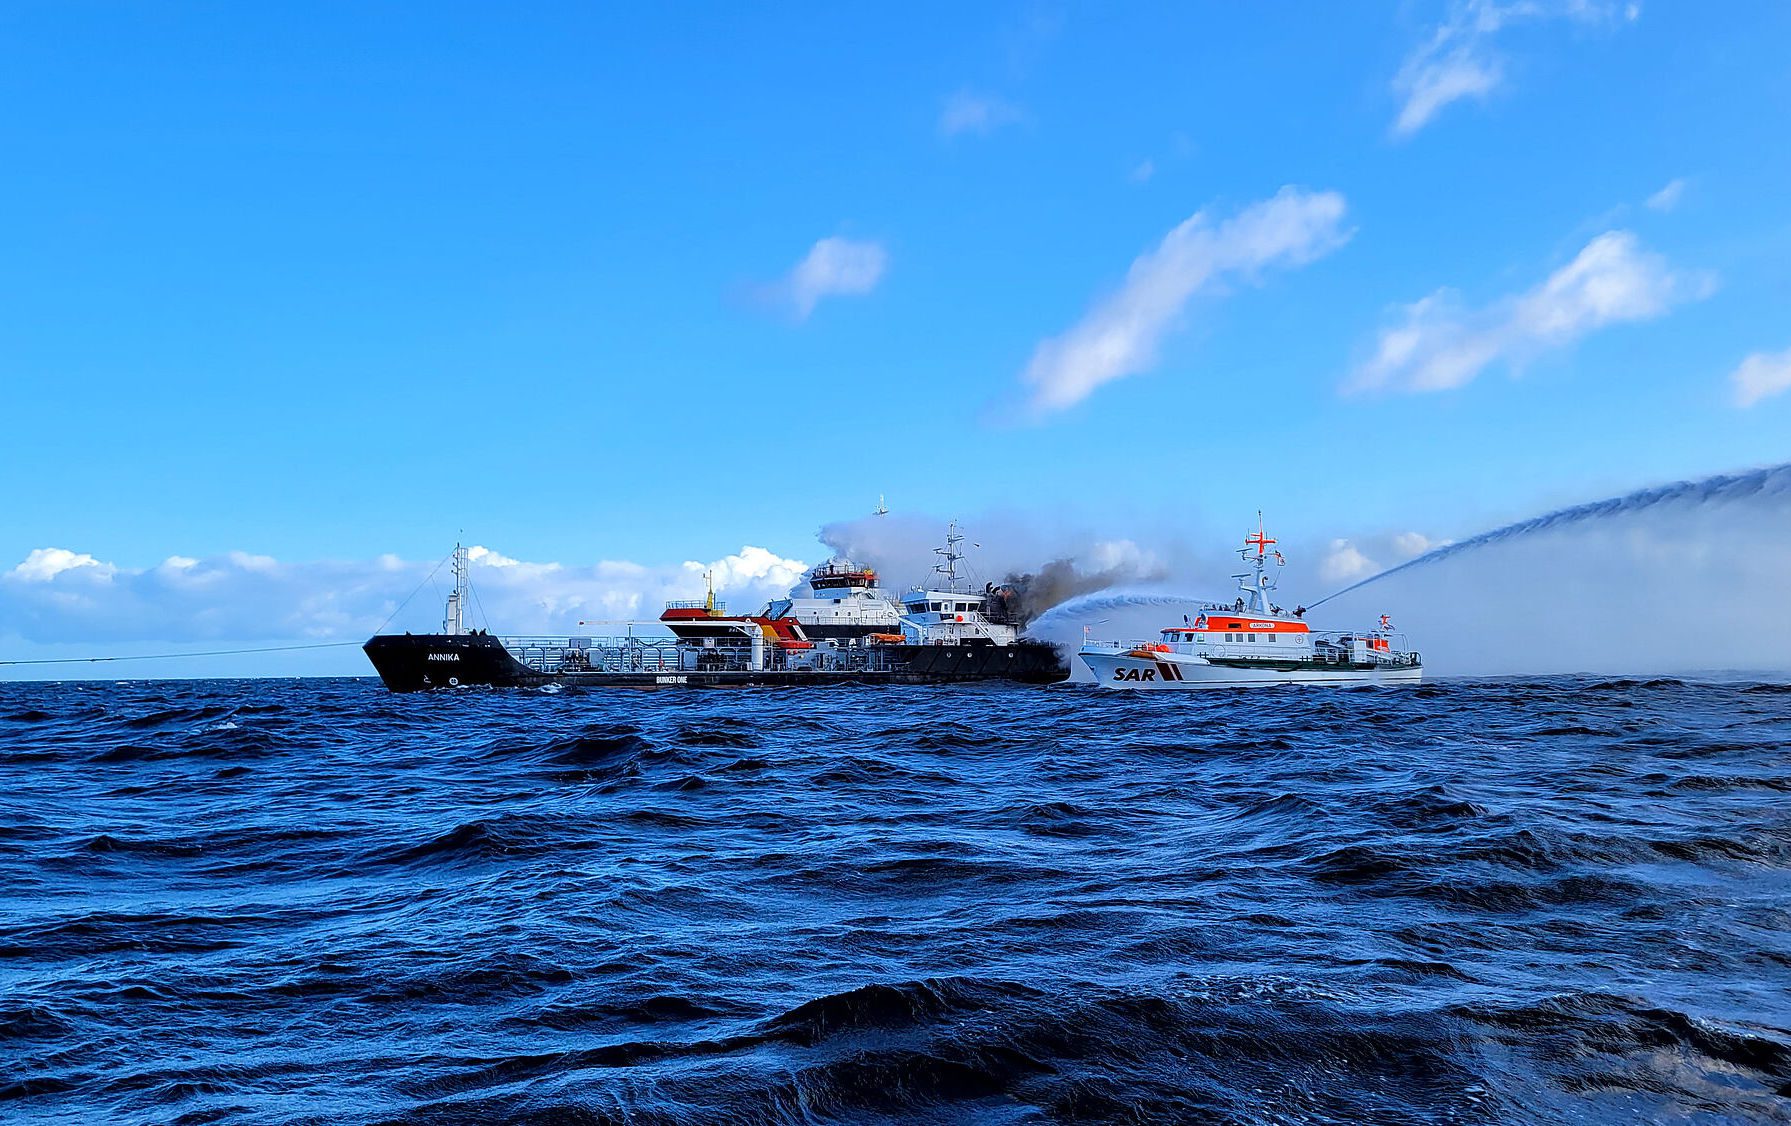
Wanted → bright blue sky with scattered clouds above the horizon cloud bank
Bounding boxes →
[0,0,1791,662]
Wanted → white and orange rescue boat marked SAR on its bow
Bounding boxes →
[1076,512,1424,691]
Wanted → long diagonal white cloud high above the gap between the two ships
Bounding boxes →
[1021,188,1350,414]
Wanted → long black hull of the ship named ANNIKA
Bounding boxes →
[362,634,1069,693]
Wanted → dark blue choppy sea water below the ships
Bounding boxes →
[0,678,1791,1126]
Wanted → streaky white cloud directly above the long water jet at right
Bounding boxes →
[1345,231,1714,390]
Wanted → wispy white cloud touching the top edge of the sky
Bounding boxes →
[1393,0,1641,136]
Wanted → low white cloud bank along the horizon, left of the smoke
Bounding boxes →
[0,546,806,644]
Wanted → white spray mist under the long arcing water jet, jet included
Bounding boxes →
[1315,464,1791,675]
